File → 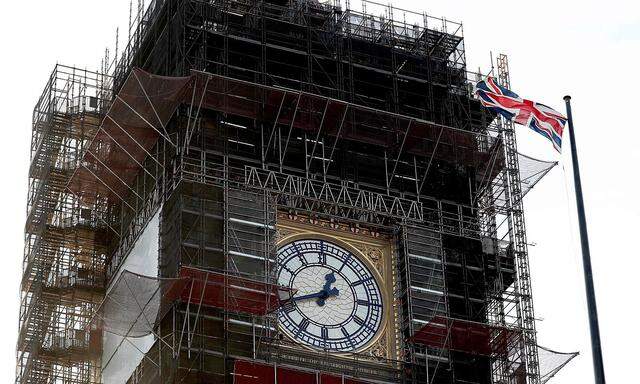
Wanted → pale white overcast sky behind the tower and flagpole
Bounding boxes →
[0,0,640,384]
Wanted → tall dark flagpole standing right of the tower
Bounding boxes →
[564,96,605,384]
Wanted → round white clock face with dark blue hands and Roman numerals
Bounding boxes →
[278,240,383,352]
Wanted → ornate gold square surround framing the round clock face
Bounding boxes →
[276,212,400,362]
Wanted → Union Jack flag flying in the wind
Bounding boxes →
[476,77,567,152]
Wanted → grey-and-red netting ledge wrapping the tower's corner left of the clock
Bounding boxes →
[91,266,293,337]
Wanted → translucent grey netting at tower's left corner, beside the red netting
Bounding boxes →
[92,270,189,337]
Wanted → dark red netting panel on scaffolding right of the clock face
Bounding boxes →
[409,316,519,356]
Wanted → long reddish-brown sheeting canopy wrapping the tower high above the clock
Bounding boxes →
[68,68,556,222]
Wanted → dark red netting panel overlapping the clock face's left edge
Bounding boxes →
[180,266,293,316]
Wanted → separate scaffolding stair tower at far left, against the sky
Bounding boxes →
[16,65,110,383]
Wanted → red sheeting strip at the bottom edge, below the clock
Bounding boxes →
[233,360,368,384]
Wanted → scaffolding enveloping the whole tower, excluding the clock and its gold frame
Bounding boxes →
[17,0,574,384]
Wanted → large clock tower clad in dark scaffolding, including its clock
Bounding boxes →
[85,0,538,384]
